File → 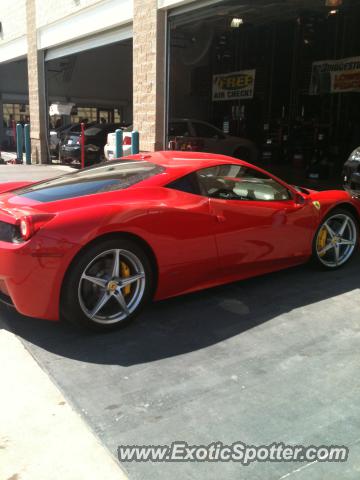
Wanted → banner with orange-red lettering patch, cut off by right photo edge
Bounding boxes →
[309,57,360,95]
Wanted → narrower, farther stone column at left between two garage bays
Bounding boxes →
[26,0,49,163]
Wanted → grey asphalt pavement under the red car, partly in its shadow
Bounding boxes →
[0,256,360,480]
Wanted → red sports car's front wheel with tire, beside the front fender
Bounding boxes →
[313,209,359,269]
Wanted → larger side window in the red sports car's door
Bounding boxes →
[197,165,291,202]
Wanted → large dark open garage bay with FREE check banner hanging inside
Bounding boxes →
[168,0,360,185]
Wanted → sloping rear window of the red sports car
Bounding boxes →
[14,161,165,203]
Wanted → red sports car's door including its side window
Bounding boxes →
[197,164,316,277]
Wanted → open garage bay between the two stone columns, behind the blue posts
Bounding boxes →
[46,35,133,161]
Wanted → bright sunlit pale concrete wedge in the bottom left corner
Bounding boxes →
[0,323,127,480]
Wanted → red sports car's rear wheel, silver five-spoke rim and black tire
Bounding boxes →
[61,238,154,330]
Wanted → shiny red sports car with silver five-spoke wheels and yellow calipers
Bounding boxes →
[0,152,360,329]
